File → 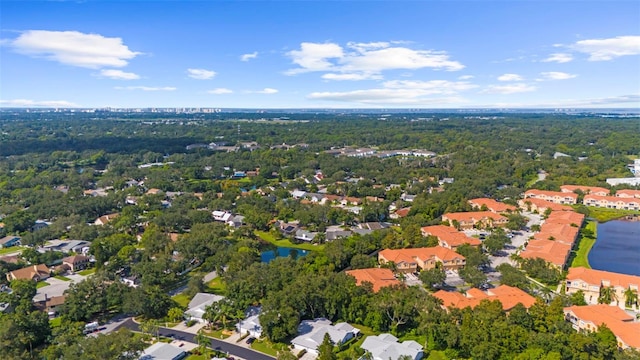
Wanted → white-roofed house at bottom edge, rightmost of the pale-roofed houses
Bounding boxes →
[360,334,424,360]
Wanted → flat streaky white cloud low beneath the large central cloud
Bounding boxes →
[307,80,477,106]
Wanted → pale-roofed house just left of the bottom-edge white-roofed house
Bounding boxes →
[291,318,360,355]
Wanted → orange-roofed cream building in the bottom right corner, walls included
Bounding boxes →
[564,304,640,349]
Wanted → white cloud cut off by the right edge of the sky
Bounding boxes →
[569,36,640,61]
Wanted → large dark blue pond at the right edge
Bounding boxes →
[589,220,640,276]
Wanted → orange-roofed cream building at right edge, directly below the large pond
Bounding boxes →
[565,267,640,308]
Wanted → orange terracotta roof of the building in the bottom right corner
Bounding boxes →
[564,304,640,348]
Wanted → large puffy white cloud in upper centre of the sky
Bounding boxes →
[286,42,464,80]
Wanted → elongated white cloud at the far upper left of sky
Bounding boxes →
[9,30,140,69]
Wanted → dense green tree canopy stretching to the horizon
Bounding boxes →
[0,111,640,360]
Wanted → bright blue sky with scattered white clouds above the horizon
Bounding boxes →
[0,0,640,108]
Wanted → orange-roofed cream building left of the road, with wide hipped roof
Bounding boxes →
[378,246,466,273]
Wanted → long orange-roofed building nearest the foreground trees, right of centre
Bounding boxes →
[433,285,536,311]
